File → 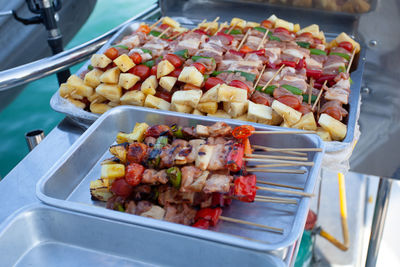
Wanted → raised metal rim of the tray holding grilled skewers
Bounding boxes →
[36,106,324,251]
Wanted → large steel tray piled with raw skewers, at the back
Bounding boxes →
[50,21,365,148]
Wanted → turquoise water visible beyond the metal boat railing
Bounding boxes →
[0,0,155,177]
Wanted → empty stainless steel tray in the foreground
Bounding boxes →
[0,204,284,267]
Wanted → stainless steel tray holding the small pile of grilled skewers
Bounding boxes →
[36,106,323,256]
